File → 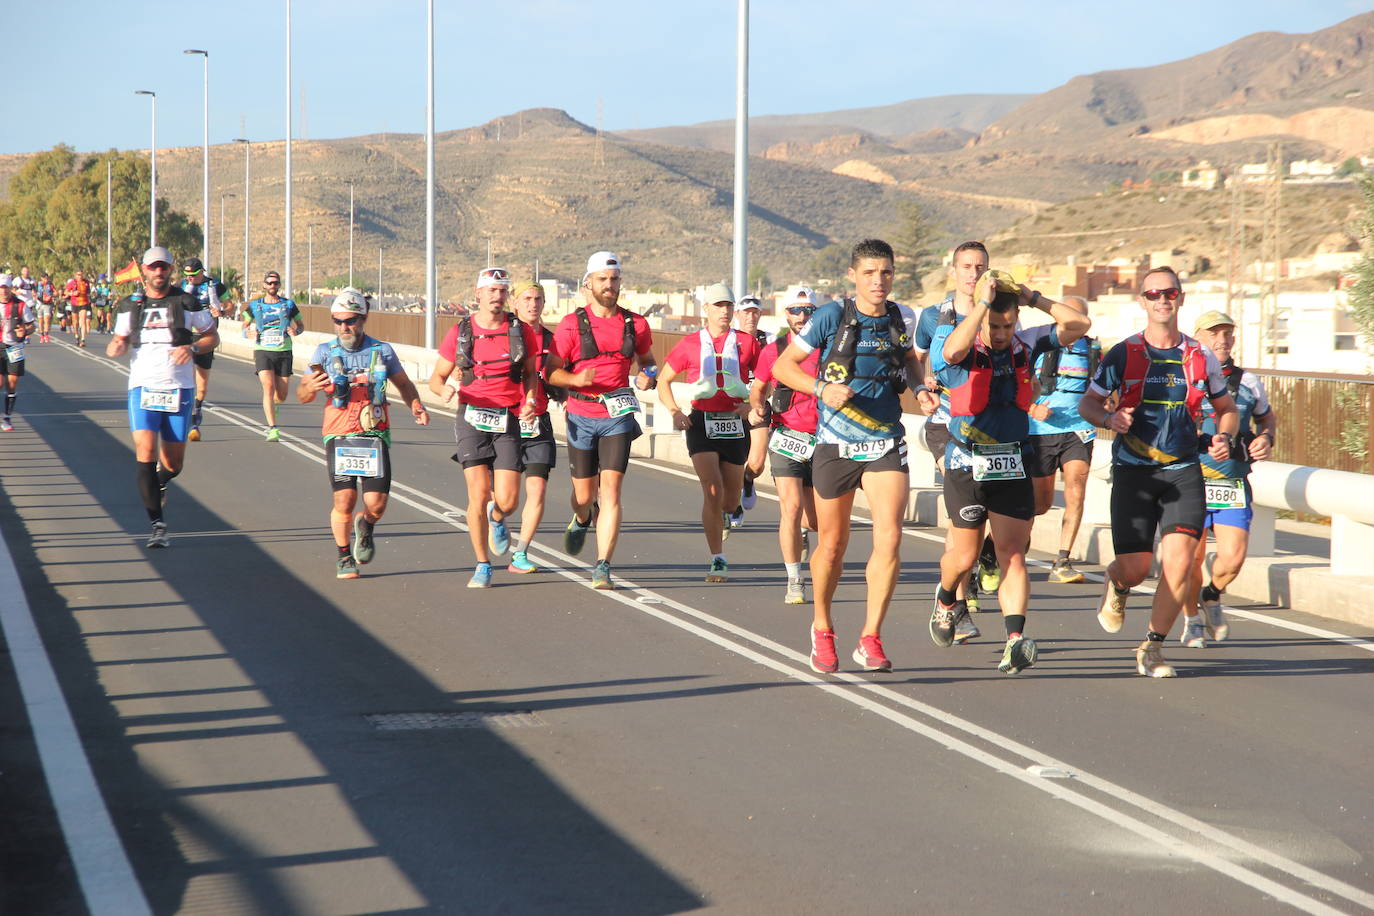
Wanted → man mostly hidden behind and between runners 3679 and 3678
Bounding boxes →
[912,240,1002,623]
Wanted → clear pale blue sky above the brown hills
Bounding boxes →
[8,0,1366,152]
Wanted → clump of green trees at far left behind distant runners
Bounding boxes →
[0,146,201,280]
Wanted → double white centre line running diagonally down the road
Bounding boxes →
[56,341,1374,913]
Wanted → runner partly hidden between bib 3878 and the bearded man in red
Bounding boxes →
[506,280,567,573]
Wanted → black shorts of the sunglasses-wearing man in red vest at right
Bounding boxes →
[1112,464,1206,555]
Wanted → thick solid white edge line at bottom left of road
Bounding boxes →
[0,436,153,916]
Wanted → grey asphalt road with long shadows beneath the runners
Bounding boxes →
[0,338,1374,916]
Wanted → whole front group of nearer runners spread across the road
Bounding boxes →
[83,239,1274,677]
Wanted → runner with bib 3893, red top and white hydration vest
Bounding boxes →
[658,283,763,582]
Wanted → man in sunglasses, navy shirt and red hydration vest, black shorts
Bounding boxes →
[1079,266,1238,677]
